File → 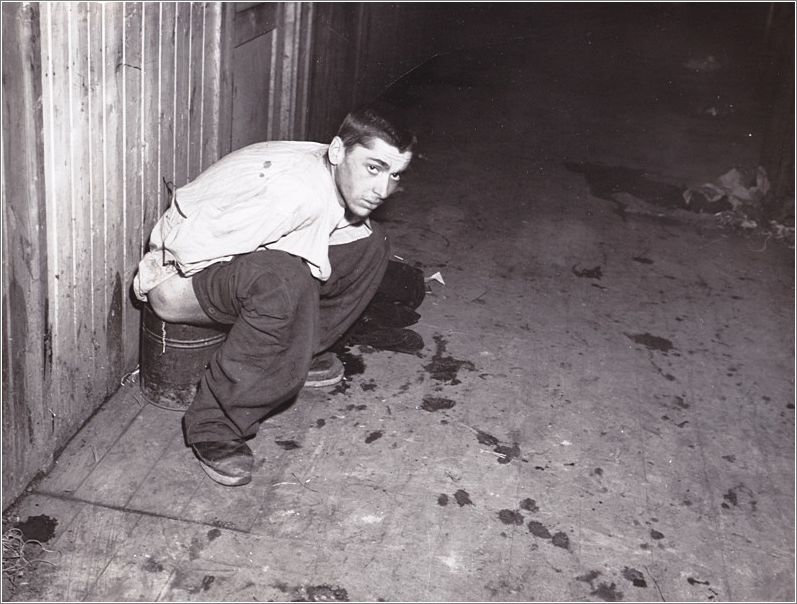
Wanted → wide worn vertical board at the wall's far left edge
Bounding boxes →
[0,3,52,507]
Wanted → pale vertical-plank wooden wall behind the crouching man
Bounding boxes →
[2,2,224,507]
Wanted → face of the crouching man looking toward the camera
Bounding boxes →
[333,138,412,218]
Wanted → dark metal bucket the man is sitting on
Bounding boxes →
[139,305,227,410]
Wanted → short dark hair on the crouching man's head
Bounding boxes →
[338,102,415,153]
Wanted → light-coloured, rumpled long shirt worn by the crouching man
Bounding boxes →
[133,141,371,301]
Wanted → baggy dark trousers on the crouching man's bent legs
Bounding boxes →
[184,221,390,444]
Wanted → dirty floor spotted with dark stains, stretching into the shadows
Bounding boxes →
[5,5,795,602]
